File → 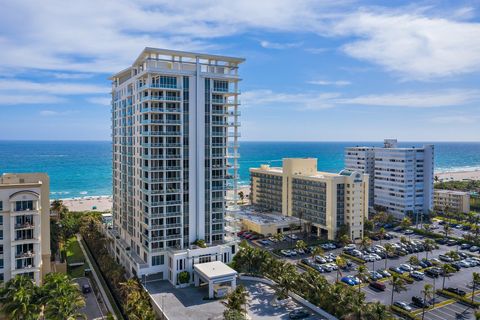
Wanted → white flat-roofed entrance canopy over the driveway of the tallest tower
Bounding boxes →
[193,261,237,299]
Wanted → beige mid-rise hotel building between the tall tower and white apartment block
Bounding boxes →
[250,158,369,239]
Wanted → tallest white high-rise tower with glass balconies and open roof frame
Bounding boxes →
[109,48,244,284]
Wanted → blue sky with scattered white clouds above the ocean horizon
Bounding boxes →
[0,0,480,141]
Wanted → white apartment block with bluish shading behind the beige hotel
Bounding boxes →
[345,139,434,218]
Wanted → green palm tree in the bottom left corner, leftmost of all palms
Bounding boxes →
[0,276,41,320]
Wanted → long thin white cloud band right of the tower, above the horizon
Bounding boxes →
[242,90,480,110]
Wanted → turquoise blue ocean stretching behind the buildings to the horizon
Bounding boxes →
[0,141,480,198]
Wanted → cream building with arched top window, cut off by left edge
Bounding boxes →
[0,173,51,284]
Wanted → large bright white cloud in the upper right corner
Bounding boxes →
[332,11,480,80]
